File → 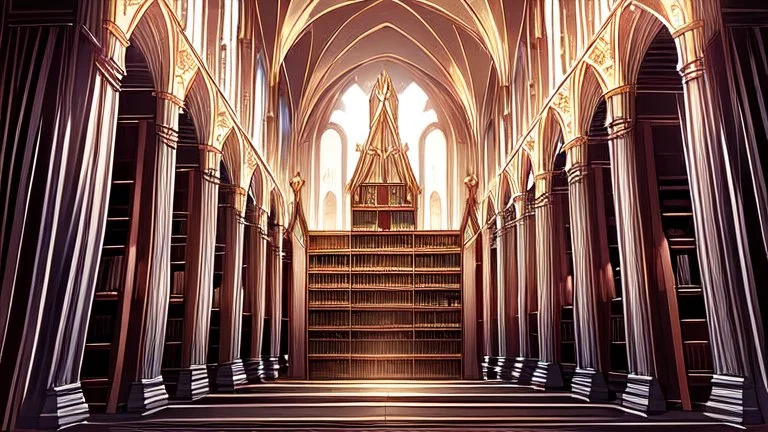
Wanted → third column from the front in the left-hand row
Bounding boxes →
[176,145,221,400]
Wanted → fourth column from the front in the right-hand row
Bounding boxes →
[533,173,563,389]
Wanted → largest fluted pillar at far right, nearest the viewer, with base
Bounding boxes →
[675,21,766,424]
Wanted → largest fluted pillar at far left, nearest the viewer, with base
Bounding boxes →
[13,27,125,429]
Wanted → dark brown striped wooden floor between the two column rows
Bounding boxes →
[69,381,738,432]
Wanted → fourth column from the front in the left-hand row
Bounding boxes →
[216,187,246,391]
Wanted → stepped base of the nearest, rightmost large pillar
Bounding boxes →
[705,375,762,424]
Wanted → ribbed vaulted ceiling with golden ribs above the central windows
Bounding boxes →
[254,0,525,152]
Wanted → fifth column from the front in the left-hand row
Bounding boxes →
[245,209,269,382]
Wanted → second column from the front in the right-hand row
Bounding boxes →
[606,86,666,412]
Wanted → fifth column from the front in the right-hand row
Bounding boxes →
[512,193,536,384]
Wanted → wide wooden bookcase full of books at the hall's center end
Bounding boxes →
[307,230,462,379]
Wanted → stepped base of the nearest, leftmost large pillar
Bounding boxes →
[35,382,90,429]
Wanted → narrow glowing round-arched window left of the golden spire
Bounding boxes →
[316,129,343,229]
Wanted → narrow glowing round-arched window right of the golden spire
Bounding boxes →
[424,129,448,229]
